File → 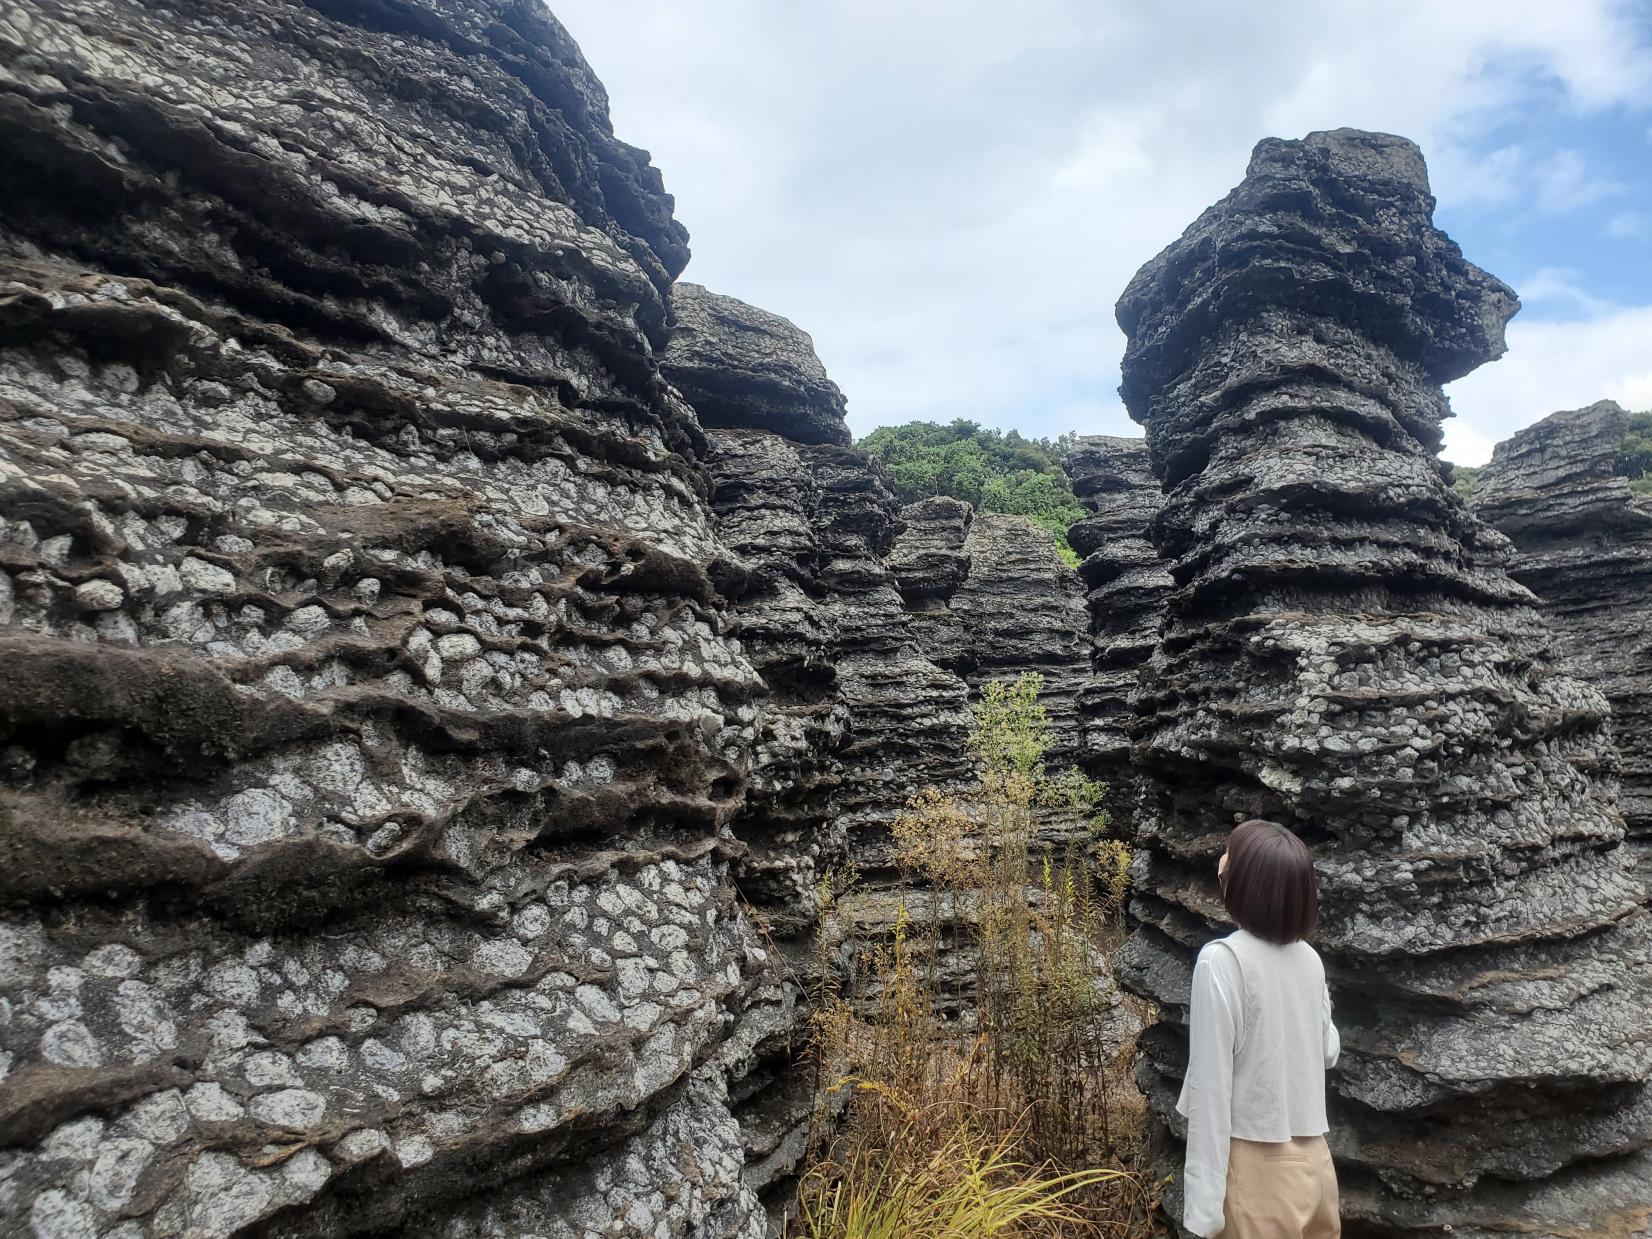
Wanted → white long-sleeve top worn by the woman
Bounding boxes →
[1176,930,1341,1237]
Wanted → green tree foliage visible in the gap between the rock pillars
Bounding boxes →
[859,418,1084,567]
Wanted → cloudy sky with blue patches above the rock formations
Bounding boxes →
[552,0,1652,464]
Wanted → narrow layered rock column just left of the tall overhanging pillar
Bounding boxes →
[1062,434,1173,814]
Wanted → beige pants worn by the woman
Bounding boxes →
[1219,1137,1341,1239]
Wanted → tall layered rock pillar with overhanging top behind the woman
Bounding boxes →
[1118,131,1652,1236]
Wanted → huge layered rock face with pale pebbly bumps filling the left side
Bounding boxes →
[0,0,779,1239]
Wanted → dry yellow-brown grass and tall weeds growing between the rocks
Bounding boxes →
[793,676,1156,1239]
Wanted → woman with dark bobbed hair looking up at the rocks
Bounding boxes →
[1176,821,1341,1239]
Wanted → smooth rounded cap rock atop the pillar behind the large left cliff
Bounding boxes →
[661,284,852,448]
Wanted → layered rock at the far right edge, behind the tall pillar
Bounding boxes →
[1470,400,1652,876]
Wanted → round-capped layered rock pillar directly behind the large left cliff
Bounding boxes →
[661,284,966,1209]
